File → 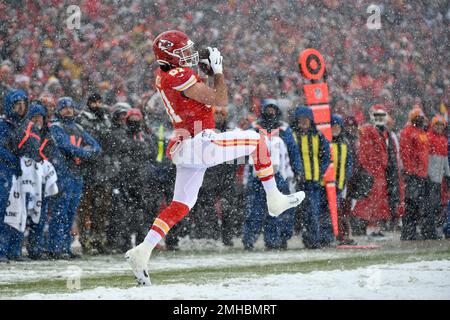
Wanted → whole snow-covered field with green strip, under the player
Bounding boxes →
[0,234,450,300]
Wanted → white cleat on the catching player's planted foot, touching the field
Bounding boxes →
[125,241,152,286]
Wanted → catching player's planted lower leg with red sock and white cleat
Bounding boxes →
[125,201,189,286]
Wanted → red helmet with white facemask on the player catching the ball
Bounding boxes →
[153,30,199,67]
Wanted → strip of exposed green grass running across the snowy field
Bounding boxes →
[0,245,450,299]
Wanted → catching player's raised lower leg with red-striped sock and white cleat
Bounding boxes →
[251,131,305,217]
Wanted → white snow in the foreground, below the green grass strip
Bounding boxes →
[17,260,450,300]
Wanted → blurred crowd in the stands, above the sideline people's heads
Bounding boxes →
[0,0,449,127]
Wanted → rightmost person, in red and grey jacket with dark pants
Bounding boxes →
[422,115,450,240]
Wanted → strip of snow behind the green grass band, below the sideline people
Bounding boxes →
[0,238,370,285]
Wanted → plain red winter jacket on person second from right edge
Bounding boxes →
[400,124,429,178]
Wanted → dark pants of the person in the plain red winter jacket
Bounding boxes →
[400,174,430,240]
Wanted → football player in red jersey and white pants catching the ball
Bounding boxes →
[125,30,305,285]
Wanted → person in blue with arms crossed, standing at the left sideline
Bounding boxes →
[48,97,101,259]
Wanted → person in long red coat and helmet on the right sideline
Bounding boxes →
[353,105,400,237]
